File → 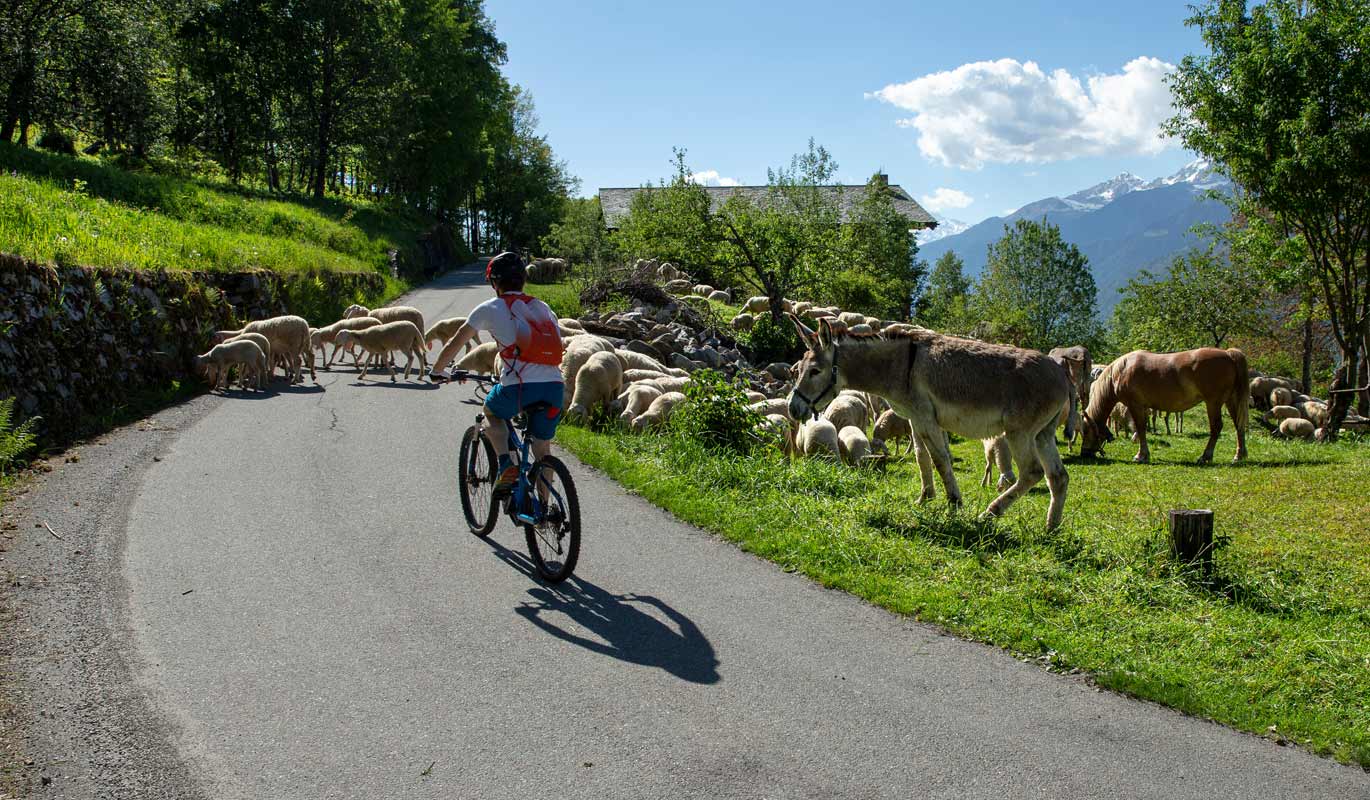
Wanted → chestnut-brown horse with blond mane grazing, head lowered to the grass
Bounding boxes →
[1080,347,1251,464]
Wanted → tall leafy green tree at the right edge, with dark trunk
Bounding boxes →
[1169,0,1370,438]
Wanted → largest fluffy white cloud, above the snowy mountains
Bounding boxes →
[866,56,1175,170]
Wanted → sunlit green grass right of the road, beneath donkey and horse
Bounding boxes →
[558,415,1370,767]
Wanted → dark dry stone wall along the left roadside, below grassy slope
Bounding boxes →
[0,253,385,442]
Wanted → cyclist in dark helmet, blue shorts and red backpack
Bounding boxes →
[429,252,566,497]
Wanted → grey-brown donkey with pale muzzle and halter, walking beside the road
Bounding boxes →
[789,314,1070,529]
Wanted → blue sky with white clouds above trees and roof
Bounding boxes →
[486,0,1201,222]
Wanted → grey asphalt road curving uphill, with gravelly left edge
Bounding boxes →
[0,265,1370,800]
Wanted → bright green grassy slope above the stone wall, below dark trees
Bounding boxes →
[0,142,425,273]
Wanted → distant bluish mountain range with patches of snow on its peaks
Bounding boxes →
[919,159,1232,310]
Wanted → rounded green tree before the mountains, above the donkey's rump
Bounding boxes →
[975,219,1100,352]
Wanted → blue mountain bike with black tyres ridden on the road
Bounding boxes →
[451,370,581,584]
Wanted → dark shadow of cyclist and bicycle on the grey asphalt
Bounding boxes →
[492,542,721,684]
